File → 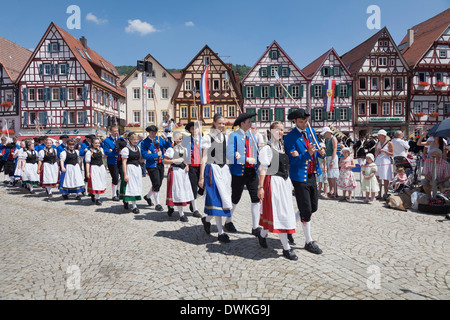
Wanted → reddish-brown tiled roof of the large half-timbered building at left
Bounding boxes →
[20,22,125,97]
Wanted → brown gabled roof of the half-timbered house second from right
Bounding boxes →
[341,27,408,75]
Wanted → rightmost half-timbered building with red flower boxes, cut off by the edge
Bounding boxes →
[399,9,450,136]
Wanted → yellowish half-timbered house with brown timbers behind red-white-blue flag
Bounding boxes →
[172,45,242,125]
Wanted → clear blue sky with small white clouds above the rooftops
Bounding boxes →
[0,0,450,69]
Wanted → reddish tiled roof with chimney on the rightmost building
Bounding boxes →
[399,8,450,67]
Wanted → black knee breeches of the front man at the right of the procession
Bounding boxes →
[292,174,319,222]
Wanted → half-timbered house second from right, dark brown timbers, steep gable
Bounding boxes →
[341,27,409,137]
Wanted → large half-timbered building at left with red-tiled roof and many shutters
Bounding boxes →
[19,22,125,136]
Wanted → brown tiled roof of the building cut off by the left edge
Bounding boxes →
[0,37,32,83]
